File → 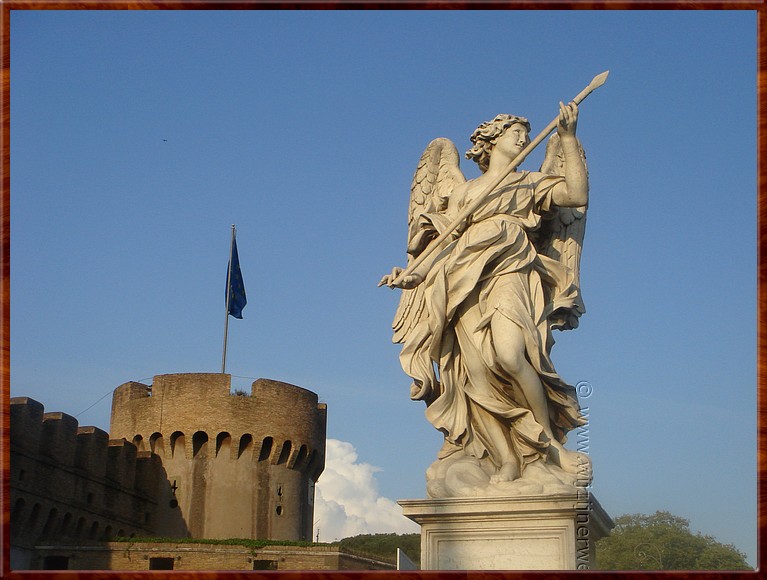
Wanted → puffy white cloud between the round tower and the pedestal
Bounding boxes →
[314,439,419,542]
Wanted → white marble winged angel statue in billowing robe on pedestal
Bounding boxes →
[379,102,590,497]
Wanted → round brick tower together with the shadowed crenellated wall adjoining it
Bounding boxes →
[11,373,326,568]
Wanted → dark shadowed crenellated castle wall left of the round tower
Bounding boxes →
[10,397,176,568]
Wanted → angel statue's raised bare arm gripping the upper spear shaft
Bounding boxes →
[552,103,589,207]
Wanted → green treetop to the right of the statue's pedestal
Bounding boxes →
[596,511,752,570]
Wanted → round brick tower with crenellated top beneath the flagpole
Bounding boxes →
[110,373,327,541]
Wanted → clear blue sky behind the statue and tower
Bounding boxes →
[11,11,757,563]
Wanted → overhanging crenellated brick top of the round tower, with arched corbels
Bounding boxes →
[111,373,327,480]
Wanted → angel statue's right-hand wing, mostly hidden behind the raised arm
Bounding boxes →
[534,133,588,330]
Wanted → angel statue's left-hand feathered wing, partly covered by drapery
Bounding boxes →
[392,138,466,343]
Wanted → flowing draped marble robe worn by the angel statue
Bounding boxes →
[395,172,584,469]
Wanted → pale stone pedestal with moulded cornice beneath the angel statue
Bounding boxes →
[398,488,613,570]
